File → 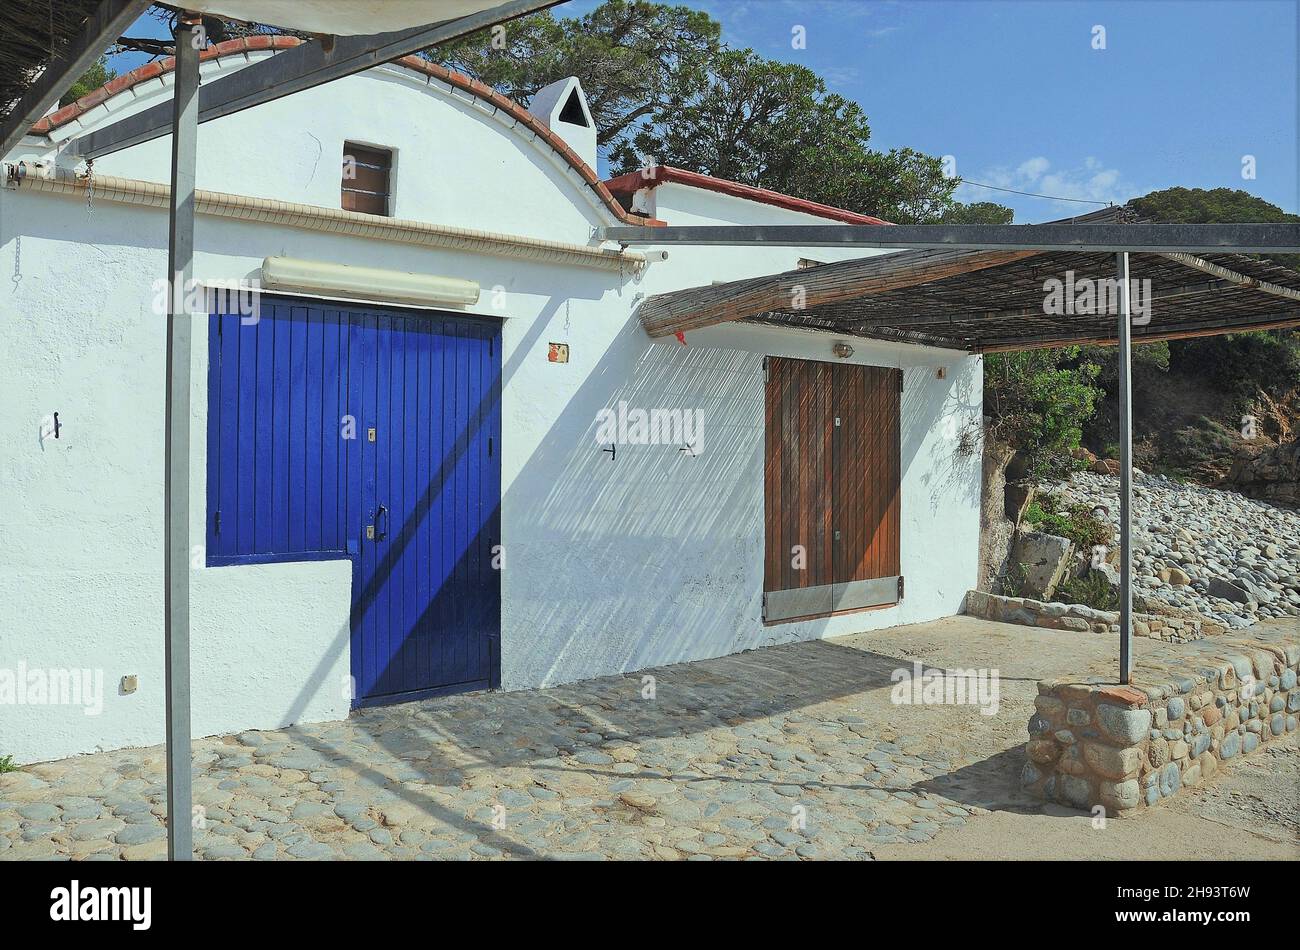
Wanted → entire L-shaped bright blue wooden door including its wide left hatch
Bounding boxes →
[207,295,501,706]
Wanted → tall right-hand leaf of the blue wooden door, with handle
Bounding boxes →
[352,306,501,706]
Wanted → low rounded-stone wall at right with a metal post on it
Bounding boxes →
[1021,632,1300,815]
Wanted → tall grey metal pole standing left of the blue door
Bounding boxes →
[164,14,203,860]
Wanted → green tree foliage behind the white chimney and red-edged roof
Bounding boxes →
[426,0,1010,224]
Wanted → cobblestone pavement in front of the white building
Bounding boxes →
[0,617,1289,860]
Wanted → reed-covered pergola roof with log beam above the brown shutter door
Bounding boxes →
[640,208,1300,352]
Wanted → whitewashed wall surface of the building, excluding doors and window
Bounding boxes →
[0,55,980,762]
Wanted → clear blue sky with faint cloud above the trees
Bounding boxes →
[113,0,1300,222]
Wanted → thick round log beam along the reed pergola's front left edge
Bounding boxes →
[640,250,1041,338]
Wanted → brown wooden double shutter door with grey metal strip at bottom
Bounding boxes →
[763,356,901,621]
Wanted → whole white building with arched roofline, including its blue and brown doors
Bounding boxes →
[0,39,982,762]
